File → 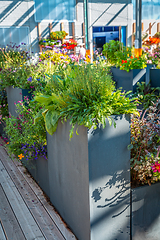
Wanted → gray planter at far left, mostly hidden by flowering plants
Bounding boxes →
[6,86,32,117]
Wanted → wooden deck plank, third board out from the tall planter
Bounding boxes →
[0,158,45,240]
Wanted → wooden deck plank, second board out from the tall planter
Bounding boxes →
[0,147,64,240]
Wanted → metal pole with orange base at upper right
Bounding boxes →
[135,0,142,57]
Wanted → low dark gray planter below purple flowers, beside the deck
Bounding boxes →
[21,157,50,197]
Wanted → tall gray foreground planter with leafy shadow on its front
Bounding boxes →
[47,116,130,240]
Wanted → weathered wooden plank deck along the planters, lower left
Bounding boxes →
[0,140,76,240]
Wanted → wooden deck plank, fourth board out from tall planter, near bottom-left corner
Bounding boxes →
[0,184,26,240]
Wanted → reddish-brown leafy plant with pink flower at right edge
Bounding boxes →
[128,100,160,187]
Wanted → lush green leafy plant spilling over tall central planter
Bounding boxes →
[35,64,137,137]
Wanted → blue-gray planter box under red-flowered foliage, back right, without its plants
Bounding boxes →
[111,67,146,92]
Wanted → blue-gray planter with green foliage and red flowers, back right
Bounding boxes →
[103,40,147,92]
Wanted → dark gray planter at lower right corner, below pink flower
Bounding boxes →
[132,183,160,240]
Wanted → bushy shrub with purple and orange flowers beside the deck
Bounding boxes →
[5,98,47,161]
